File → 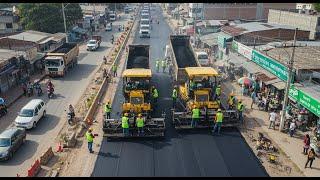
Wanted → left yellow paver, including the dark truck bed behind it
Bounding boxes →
[103,45,165,138]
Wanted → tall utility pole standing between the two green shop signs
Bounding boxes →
[279,28,298,131]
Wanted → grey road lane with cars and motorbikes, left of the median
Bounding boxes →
[0,15,129,176]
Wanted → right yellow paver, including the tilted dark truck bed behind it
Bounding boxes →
[169,35,239,130]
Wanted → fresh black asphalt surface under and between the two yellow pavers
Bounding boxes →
[92,6,268,177]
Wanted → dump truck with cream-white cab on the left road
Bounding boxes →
[44,43,79,77]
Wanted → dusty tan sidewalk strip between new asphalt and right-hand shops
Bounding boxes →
[222,74,320,177]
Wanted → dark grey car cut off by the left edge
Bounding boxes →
[0,127,26,161]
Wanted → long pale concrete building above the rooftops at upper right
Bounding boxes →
[268,9,320,40]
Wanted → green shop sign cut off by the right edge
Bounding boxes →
[289,85,320,117]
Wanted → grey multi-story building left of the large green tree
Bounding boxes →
[0,8,21,35]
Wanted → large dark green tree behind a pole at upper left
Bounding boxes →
[18,3,82,33]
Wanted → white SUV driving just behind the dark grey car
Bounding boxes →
[15,99,47,129]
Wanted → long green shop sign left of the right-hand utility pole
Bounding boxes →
[251,50,288,81]
